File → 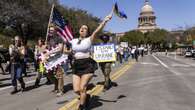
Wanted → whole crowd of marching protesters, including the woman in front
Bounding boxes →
[2,15,147,110]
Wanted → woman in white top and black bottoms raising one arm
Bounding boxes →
[71,13,112,110]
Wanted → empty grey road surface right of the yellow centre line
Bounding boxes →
[91,55,195,110]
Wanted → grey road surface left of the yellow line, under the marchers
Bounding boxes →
[0,60,125,110]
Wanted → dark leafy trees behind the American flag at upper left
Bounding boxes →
[0,0,101,40]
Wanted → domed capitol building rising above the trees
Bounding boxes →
[137,0,158,33]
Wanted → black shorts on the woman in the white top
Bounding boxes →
[73,58,98,75]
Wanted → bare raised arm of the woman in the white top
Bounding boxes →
[90,9,113,41]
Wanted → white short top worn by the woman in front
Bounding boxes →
[70,37,92,59]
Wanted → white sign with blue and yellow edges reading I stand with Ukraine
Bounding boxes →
[93,44,116,62]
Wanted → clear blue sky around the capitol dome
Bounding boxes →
[59,0,195,33]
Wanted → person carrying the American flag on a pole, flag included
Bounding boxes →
[41,5,73,96]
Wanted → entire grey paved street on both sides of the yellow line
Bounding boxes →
[0,54,195,110]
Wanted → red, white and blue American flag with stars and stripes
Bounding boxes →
[51,8,73,42]
